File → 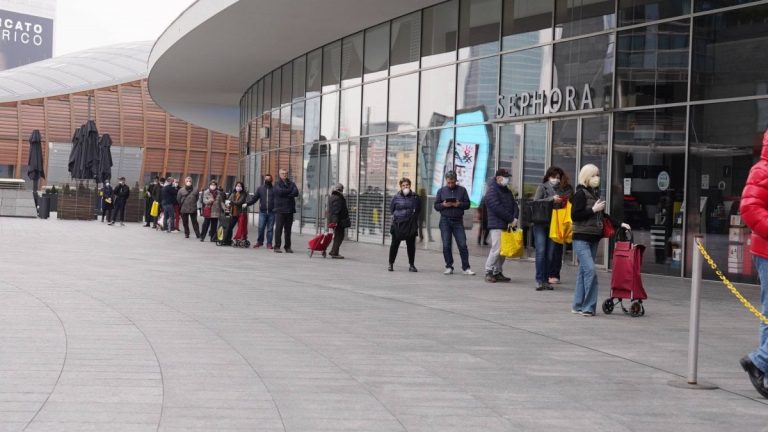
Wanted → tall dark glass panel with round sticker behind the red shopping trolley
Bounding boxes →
[616,107,685,275]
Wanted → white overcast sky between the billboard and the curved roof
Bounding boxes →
[53,0,194,56]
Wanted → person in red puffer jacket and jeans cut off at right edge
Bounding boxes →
[739,125,768,398]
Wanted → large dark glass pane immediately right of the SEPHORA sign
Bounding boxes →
[616,20,689,107]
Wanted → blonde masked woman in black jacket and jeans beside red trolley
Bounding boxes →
[571,164,630,317]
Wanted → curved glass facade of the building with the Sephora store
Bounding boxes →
[240,0,768,282]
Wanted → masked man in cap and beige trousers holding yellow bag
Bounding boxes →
[485,168,520,283]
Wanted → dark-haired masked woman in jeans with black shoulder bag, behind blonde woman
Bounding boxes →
[533,166,573,291]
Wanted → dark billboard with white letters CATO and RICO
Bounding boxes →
[0,9,53,70]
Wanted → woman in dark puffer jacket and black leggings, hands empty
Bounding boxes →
[388,177,421,273]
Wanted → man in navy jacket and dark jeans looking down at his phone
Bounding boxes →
[435,171,475,276]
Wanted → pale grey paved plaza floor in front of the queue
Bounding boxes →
[0,218,768,432]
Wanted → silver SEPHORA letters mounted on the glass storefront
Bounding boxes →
[496,84,594,119]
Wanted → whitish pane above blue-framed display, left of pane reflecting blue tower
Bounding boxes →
[419,65,456,127]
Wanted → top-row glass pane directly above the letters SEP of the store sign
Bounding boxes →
[502,0,555,50]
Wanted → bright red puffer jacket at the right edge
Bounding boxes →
[740,130,768,258]
